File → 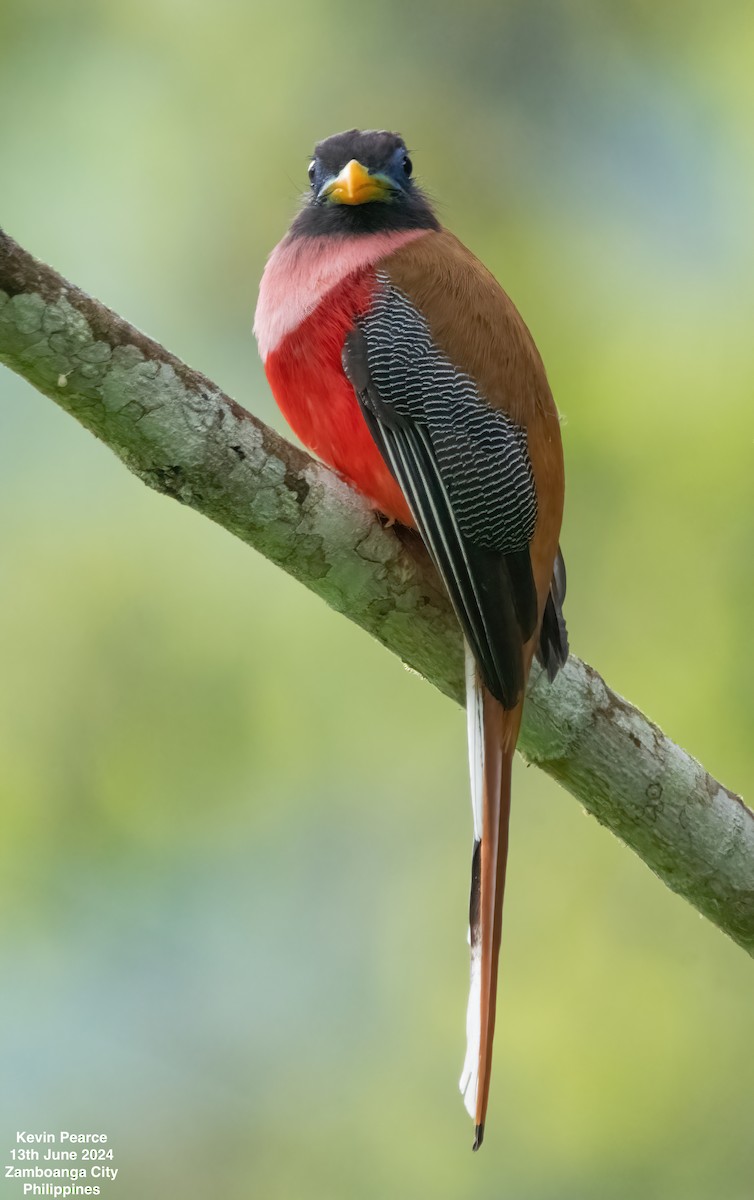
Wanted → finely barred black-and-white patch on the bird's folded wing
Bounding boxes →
[359,275,537,553]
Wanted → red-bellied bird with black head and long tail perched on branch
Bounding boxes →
[253,130,568,1150]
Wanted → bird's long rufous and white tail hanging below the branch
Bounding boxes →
[460,648,522,1150]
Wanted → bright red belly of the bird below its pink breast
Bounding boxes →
[264,271,414,526]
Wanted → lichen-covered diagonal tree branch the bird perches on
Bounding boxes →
[0,232,754,954]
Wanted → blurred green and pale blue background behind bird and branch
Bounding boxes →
[0,0,754,1200]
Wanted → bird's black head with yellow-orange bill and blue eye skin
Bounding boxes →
[291,130,439,236]
